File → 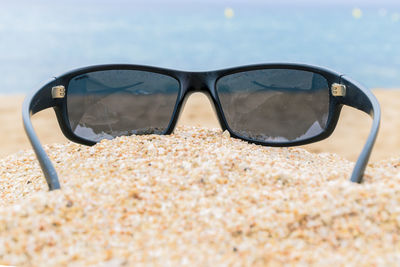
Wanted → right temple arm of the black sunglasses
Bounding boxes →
[339,76,381,183]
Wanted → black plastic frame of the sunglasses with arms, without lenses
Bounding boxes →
[22,63,380,190]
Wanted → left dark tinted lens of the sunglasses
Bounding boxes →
[67,70,179,141]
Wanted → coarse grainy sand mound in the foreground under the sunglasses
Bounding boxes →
[0,128,400,266]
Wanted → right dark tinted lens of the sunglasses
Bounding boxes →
[216,69,329,143]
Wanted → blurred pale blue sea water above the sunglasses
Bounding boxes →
[0,0,400,94]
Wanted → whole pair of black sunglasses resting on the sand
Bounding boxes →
[22,64,380,190]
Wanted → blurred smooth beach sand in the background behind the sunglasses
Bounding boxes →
[0,90,400,161]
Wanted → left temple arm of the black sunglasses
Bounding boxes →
[22,80,60,190]
